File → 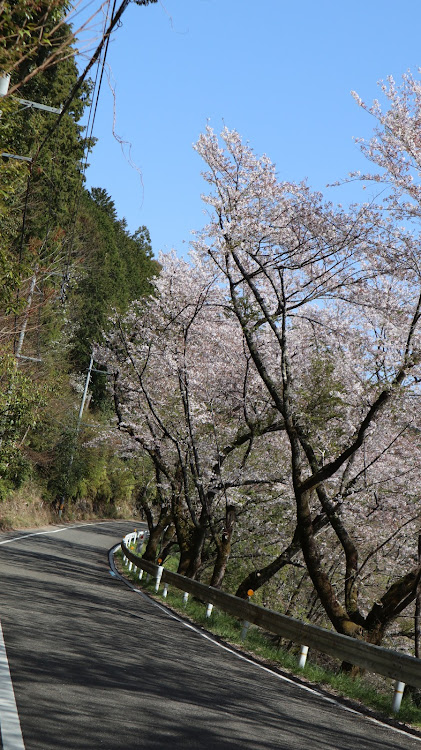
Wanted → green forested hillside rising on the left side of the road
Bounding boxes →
[0,2,158,526]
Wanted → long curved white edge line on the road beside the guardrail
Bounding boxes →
[109,544,421,742]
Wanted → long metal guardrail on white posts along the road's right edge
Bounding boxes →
[121,531,421,713]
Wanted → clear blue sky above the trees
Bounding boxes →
[80,0,421,254]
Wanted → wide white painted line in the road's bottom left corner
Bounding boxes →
[0,623,25,750]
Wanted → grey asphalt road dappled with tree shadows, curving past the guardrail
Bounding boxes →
[0,522,421,750]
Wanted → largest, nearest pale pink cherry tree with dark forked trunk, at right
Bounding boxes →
[195,125,421,643]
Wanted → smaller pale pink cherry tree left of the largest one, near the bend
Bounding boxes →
[97,254,283,586]
